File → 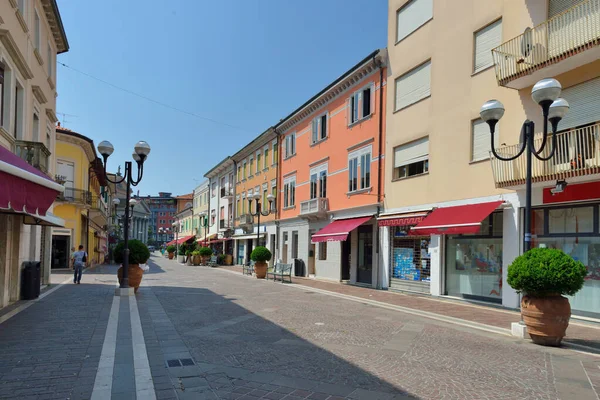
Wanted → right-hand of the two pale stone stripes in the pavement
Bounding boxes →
[129,296,156,400]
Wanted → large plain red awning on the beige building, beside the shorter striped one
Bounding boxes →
[411,201,503,235]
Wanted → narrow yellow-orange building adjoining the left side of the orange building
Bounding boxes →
[232,128,279,264]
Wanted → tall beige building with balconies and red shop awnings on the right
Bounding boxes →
[378,0,600,315]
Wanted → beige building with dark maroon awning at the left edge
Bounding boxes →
[0,0,69,308]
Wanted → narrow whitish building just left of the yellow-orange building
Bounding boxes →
[204,156,235,257]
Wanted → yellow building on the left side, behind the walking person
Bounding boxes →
[51,126,110,268]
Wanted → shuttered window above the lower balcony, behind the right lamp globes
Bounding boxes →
[558,78,600,130]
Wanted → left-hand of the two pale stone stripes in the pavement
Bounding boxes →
[92,296,121,400]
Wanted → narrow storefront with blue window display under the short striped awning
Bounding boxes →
[378,211,431,294]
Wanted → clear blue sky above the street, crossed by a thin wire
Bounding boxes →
[57,0,387,195]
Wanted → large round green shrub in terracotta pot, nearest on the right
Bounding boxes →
[507,248,587,346]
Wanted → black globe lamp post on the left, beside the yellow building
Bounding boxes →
[98,140,150,288]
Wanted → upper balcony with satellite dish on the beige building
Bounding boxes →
[492,0,600,89]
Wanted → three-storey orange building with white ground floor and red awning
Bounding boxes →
[275,50,387,286]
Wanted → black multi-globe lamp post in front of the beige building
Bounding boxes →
[479,78,569,252]
